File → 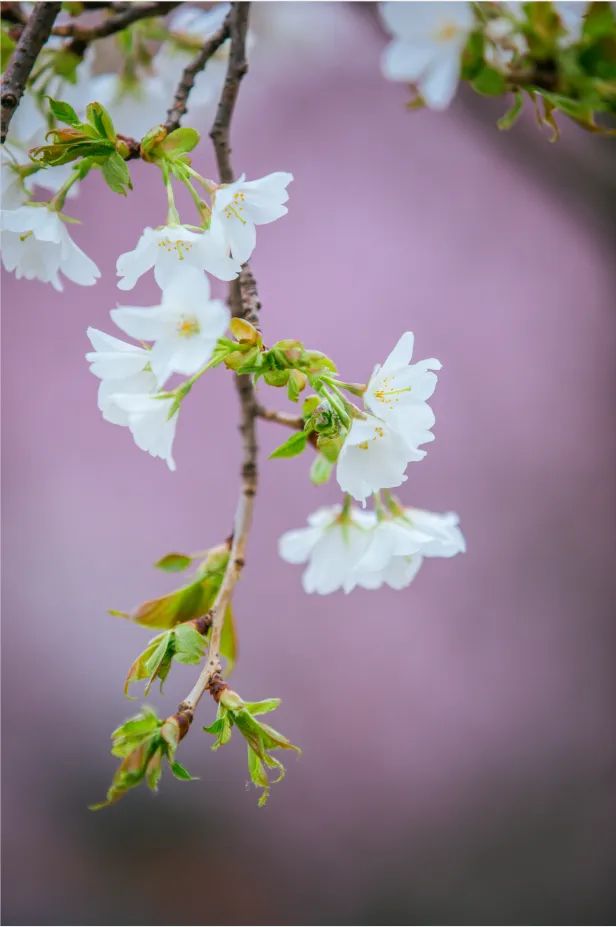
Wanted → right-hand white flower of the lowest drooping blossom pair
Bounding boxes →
[355,508,466,589]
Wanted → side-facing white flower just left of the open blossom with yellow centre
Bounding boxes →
[86,328,162,425]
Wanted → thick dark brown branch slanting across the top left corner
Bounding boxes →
[0,2,61,144]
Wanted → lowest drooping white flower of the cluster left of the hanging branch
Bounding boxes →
[110,392,178,470]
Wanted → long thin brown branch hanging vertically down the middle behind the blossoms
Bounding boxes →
[175,2,260,724]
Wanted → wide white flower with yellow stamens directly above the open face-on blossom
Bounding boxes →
[116,225,240,290]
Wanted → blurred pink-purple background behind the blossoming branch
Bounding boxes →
[2,3,616,924]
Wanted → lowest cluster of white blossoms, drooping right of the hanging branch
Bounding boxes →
[279,498,466,595]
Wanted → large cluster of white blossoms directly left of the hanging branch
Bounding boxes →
[86,173,293,470]
